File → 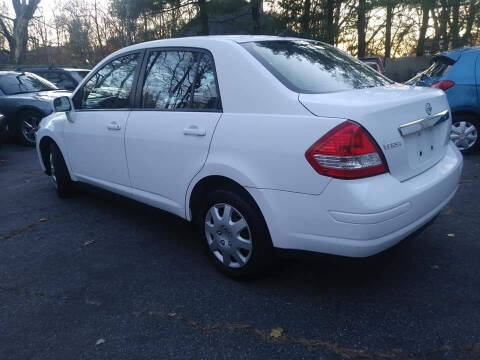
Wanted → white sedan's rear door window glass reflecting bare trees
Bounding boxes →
[141,50,219,110]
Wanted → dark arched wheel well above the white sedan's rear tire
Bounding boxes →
[189,175,262,221]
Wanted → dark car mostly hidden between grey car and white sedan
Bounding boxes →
[17,66,90,91]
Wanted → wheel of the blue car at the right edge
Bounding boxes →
[450,114,480,154]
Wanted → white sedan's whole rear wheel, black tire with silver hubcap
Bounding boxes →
[197,190,273,278]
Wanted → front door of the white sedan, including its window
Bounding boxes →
[64,52,141,191]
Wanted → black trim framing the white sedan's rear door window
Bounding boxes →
[130,46,223,113]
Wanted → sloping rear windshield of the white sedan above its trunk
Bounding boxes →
[242,40,393,94]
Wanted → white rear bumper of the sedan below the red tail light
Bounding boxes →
[249,144,463,257]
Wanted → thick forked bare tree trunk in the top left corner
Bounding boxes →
[0,0,40,64]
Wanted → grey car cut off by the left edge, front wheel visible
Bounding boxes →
[0,71,70,146]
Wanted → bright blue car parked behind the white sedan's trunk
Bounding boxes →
[406,47,480,153]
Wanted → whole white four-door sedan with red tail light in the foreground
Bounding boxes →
[37,36,462,277]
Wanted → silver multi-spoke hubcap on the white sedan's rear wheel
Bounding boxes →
[205,204,252,268]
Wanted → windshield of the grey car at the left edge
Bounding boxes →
[0,73,57,95]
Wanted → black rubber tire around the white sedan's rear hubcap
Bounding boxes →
[195,189,274,279]
